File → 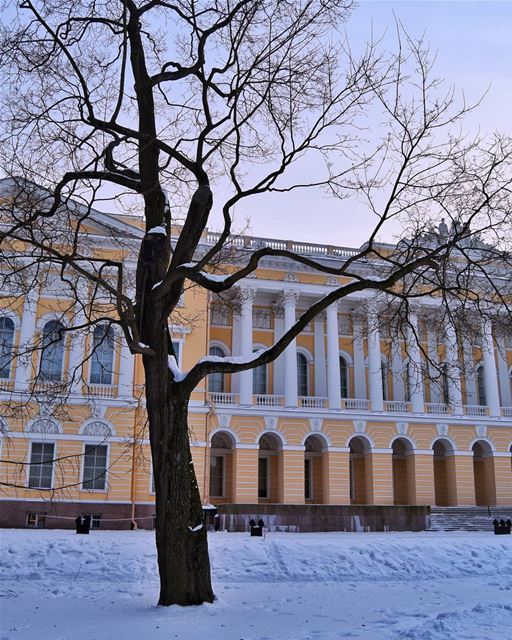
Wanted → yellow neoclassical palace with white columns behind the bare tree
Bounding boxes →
[0,191,512,528]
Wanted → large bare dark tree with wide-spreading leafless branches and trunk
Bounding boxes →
[0,0,511,605]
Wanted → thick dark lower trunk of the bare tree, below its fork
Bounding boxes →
[144,358,214,605]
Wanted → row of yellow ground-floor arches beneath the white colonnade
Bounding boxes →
[207,428,512,506]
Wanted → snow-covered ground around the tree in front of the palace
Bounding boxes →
[0,530,512,640]
